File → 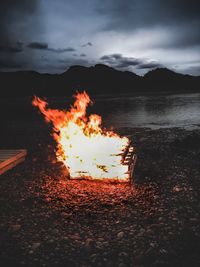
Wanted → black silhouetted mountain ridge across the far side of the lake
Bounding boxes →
[0,64,200,97]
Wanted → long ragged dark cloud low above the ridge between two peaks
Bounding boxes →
[100,54,161,69]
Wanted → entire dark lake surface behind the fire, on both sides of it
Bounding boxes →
[0,93,200,129]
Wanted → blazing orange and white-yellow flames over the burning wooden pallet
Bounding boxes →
[32,92,130,180]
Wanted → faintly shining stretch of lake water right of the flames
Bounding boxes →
[92,94,200,128]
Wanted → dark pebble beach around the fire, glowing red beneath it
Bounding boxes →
[0,125,200,267]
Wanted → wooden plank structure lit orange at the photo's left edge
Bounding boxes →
[0,149,27,175]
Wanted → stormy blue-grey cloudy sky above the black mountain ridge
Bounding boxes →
[0,0,200,75]
